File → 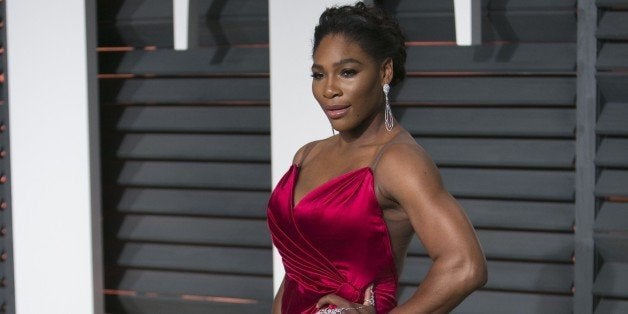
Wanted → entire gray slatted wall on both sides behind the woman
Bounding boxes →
[99,0,628,313]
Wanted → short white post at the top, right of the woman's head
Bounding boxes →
[454,0,482,46]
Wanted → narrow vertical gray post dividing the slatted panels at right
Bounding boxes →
[573,0,597,314]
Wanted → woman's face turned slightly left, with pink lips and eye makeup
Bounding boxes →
[312,34,392,132]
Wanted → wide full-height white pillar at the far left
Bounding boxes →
[6,0,103,314]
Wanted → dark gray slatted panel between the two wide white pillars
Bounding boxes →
[98,0,272,313]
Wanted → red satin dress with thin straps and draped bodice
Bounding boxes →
[268,161,397,314]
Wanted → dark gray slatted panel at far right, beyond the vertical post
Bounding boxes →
[593,0,628,313]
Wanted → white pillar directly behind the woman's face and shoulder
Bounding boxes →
[268,0,355,291]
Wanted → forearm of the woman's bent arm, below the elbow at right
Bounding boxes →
[390,260,487,314]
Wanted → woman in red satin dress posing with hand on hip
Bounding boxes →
[268,2,487,314]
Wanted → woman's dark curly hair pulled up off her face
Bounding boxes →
[312,2,406,85]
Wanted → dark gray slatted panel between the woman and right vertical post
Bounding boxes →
[385,0,577,313]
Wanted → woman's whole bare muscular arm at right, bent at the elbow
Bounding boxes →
[376,144,487,313]
